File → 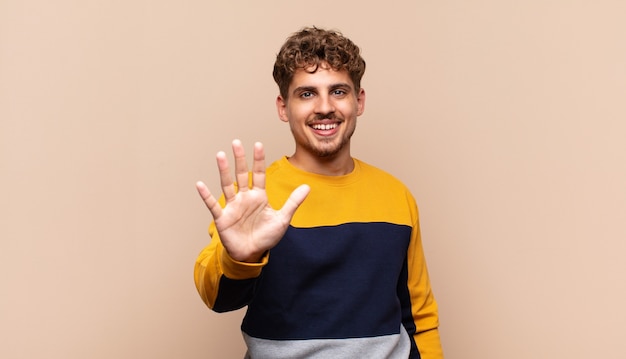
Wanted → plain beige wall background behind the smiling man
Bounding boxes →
[0,0,626,359]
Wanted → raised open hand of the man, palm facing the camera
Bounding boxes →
[196,140,310,262]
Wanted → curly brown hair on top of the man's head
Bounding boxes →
[273,27,365,99]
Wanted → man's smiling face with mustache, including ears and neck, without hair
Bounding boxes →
[276,63,365,160]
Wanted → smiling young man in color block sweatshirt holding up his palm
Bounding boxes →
[194,28,443,359]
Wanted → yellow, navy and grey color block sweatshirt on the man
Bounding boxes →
[194,157,443,359]
